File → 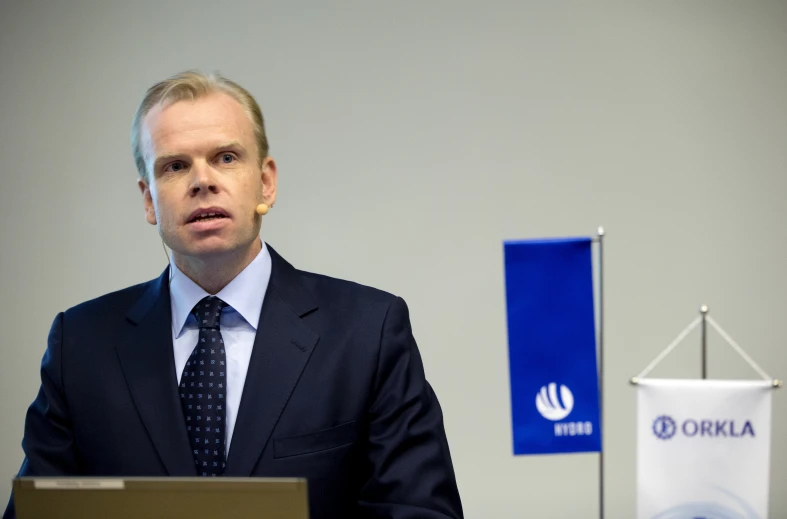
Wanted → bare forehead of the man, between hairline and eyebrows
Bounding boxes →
[141,92,254,158]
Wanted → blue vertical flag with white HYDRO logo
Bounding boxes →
[504,238,601,454]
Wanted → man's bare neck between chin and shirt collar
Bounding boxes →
[172,239,262,295]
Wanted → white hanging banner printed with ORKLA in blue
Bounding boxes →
[637,379,772,519]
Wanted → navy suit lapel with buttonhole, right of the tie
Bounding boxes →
[225,247,319,477]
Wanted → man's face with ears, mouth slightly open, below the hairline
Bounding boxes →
[139,93,276,261]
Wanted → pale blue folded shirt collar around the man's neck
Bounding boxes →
[169,241,271,337]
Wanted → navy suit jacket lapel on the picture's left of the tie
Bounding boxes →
[117,268,196,476]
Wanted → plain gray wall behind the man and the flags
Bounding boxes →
[0,0,787,519]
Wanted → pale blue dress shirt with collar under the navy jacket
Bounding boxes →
[169,242,271,454]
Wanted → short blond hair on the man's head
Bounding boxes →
[131,70,268,179]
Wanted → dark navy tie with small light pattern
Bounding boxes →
[180,296,227,476]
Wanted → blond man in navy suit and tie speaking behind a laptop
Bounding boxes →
[5,72,462,519]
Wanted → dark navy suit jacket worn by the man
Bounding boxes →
[4,248,462,519]
